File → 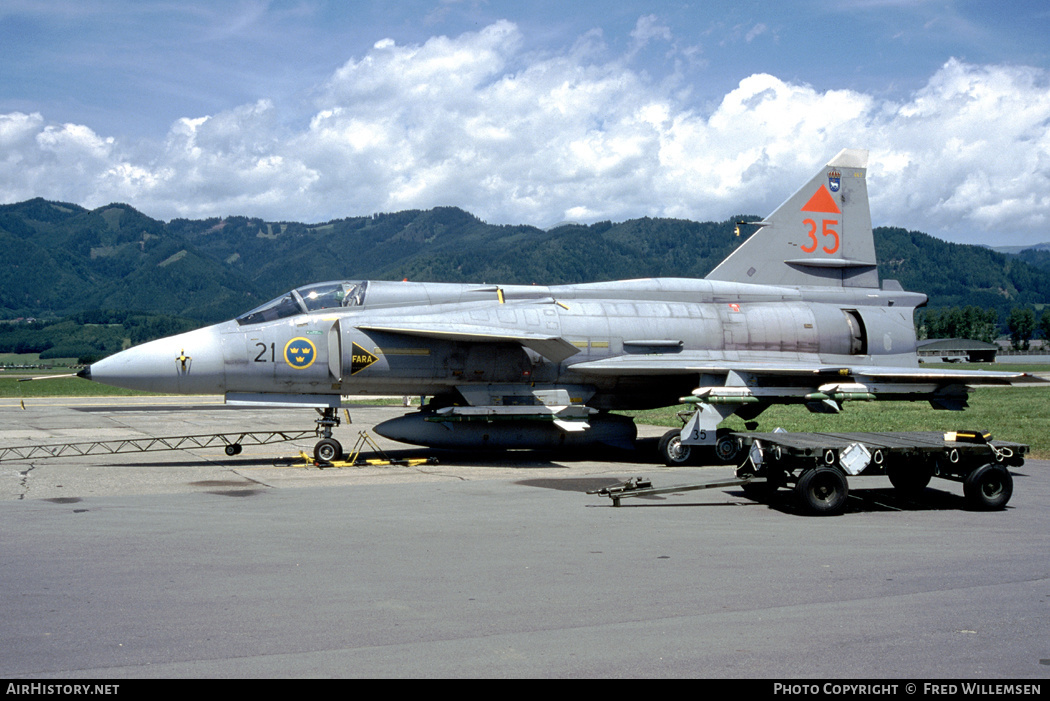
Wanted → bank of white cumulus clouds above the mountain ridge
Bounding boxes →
[0,18,1050,243]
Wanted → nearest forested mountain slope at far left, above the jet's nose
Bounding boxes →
[0,199,257,320]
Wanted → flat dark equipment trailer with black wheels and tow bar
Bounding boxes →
[589,431,1029,515]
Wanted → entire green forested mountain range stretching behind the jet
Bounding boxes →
[0,198,1050,322]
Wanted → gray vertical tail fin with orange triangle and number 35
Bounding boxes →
[707,149,879,288]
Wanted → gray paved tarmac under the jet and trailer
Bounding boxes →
[0,398,1050,680]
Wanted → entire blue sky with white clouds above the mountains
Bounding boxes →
[0,0,1050,246]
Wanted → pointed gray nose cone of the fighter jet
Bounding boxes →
[79,326,226,395]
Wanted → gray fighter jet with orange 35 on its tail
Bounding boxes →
[80,149,1031,464]
